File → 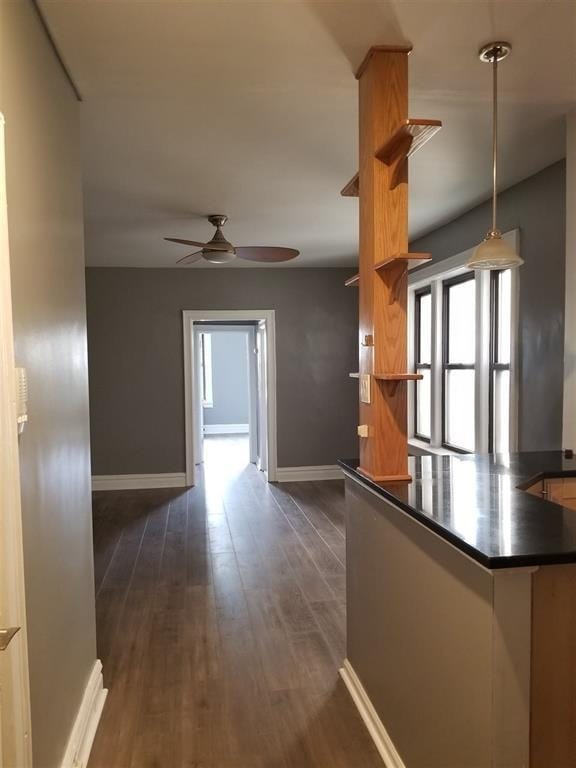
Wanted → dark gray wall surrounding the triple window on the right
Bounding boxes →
[410,161,566,451]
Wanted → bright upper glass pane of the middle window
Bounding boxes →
[448,280,476,364]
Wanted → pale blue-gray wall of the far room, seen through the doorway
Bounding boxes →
[204,331,249,424]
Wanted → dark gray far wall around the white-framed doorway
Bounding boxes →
[86,267,358,475]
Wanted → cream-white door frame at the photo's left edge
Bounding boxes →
[0,113,32,768]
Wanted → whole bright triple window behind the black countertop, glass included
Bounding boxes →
[408,235,519,453]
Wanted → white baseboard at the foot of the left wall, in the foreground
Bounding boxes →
[60,659,108,768]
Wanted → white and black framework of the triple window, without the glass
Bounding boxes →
[408,230,520,455]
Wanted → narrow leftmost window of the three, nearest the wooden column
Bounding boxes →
[414,288,432,442]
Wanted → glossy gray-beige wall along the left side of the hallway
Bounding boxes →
[0,2,96,768]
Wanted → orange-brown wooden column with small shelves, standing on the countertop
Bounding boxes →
[341,46,442,482]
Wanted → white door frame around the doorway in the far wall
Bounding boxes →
[182,309,277,485]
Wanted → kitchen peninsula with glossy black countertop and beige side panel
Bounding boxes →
[341,452,576,768]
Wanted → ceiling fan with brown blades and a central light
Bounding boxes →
[164,214,300,264]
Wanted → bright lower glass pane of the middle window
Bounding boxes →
[445,369,476,451]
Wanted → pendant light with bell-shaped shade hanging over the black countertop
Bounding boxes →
[466,42,524,269]
